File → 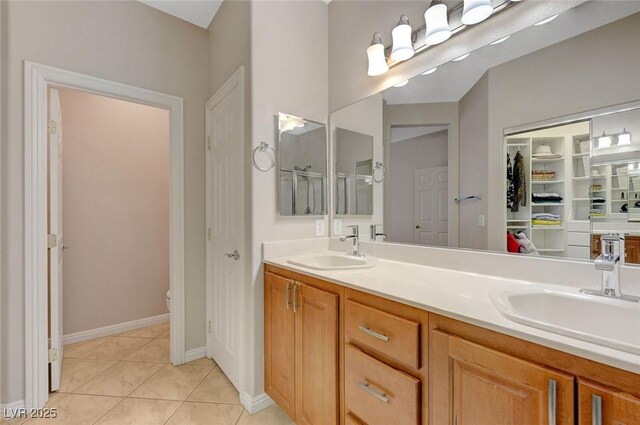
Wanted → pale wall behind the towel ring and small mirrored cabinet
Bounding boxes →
[247,0,329,395]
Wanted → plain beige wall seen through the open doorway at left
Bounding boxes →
[60,90,170,335]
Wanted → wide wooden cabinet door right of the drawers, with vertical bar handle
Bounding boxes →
[429,330,574,425]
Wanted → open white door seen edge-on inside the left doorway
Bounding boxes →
[47,89,64,391]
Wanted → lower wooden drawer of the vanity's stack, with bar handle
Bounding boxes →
[345,344,420,425]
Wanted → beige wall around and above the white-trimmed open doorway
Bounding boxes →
[0,1,208,402]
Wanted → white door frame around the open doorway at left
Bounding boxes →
[24,61,185,409]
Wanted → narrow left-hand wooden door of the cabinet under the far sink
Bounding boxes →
[264,273,295,418]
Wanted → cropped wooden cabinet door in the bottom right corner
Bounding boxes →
[578,380,640,425]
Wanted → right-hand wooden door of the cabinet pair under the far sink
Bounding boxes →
[294,284,339,425]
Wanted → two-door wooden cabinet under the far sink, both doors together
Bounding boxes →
[264,273,340,425]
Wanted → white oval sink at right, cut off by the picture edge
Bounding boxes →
[491,285,640,355]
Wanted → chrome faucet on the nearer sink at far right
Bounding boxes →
[580,234,640,302]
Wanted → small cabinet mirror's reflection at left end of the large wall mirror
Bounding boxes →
[334,128,373,215]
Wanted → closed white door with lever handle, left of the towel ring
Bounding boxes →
[207,72,244,388]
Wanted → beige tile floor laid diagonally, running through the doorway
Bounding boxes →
[0,324,293,425]
